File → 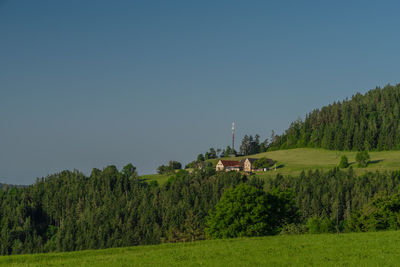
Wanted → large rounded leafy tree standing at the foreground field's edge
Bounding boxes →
[206,184,298,238]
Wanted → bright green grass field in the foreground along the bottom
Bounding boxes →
[0,231,400,267]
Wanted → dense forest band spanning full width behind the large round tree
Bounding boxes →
[0,164,400,254]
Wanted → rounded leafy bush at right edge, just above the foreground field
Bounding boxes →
[348,194,400,232]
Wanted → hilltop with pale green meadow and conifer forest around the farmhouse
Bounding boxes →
[147,84,400,183]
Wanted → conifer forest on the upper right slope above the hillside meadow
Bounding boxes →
[269,84,400,151]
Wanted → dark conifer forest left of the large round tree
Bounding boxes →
[0,164,246,254]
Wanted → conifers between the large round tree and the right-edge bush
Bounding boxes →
[265,170,400,232]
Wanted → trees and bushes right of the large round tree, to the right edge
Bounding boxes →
[265,170,400,233]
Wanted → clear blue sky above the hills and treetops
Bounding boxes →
[0,0,400,184]
